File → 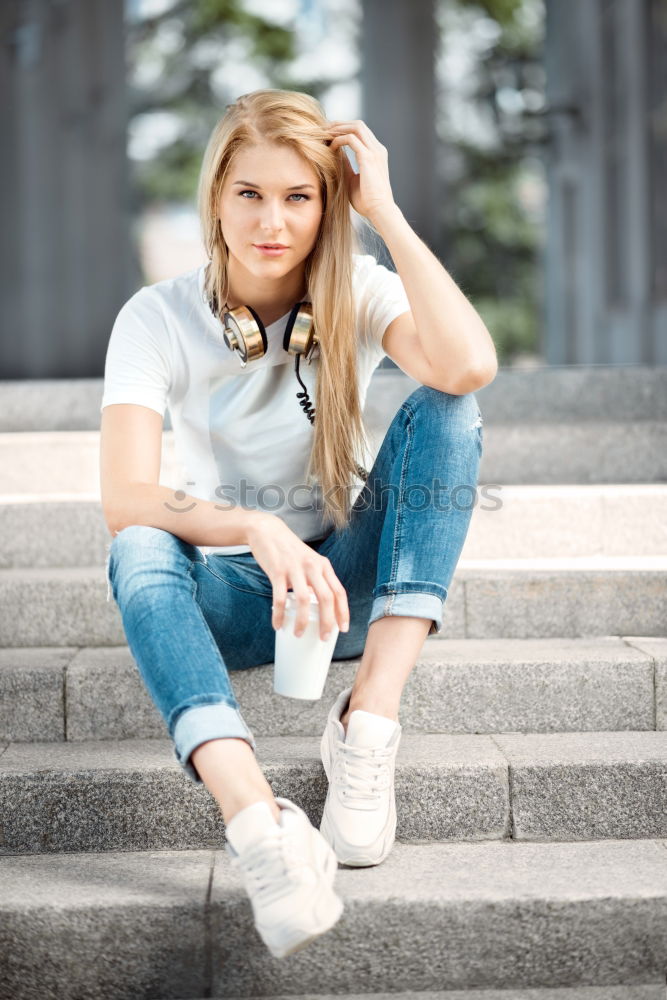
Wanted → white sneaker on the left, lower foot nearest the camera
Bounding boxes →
[226,798,343,958]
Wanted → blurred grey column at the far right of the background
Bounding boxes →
[544,0,667,364]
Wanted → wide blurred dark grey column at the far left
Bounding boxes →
[0,0,135,378]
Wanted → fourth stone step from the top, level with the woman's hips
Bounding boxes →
[0,556,667,655]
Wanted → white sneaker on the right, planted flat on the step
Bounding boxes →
[320,688,402,868]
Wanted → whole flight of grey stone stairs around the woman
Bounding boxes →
[0,366,667,1000]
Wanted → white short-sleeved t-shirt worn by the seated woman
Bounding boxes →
[100,254,410,554]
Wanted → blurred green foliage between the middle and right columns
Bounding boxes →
[442,0,544,365]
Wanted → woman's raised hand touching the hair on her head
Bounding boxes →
[329,121,396,222]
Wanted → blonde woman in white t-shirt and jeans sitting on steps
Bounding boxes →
[101,90,497,957]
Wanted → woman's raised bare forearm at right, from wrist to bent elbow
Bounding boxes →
[371,205,497,380]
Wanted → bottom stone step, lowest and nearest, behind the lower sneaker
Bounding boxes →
[0,840,667,1000]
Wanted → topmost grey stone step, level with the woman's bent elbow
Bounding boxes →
[0,365,667,432]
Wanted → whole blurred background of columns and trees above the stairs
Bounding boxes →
[0,0,667,379]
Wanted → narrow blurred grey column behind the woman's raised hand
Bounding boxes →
[361,0,440,251]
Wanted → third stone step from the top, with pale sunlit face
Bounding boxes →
[0,483,667,569]
